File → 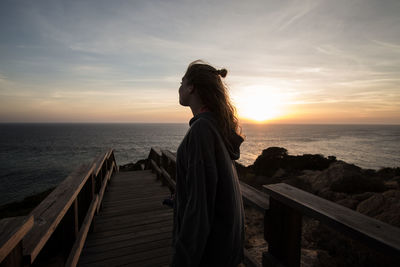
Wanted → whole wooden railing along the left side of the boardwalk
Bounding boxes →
[0,149,118,266]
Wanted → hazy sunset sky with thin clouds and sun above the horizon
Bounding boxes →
[0,0,400,124]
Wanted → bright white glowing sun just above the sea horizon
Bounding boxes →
[234,86,287,122]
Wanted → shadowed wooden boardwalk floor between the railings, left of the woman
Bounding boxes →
[78,170,173,266]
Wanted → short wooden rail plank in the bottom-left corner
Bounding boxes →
[0,215,33,263]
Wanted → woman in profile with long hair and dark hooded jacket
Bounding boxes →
[172,61,244,267]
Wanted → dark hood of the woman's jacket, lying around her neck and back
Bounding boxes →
[189,111,244,160]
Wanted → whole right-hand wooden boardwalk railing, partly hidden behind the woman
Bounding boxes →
[147,148,400,266]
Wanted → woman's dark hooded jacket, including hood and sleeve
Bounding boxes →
[172,112,244,267]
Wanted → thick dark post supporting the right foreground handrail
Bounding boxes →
[263,197,302,267]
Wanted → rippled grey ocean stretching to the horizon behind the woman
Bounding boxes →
[0,123,400,205]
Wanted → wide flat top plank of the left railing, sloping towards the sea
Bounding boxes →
[23,165,94,263]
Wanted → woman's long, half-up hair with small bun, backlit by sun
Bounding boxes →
[185,60,241,139]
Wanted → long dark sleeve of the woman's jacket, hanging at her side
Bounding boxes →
[172,121,218,267]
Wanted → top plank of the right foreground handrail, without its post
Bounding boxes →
[263,183,400,258]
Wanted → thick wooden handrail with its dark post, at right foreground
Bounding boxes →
[263,183,400,266]
